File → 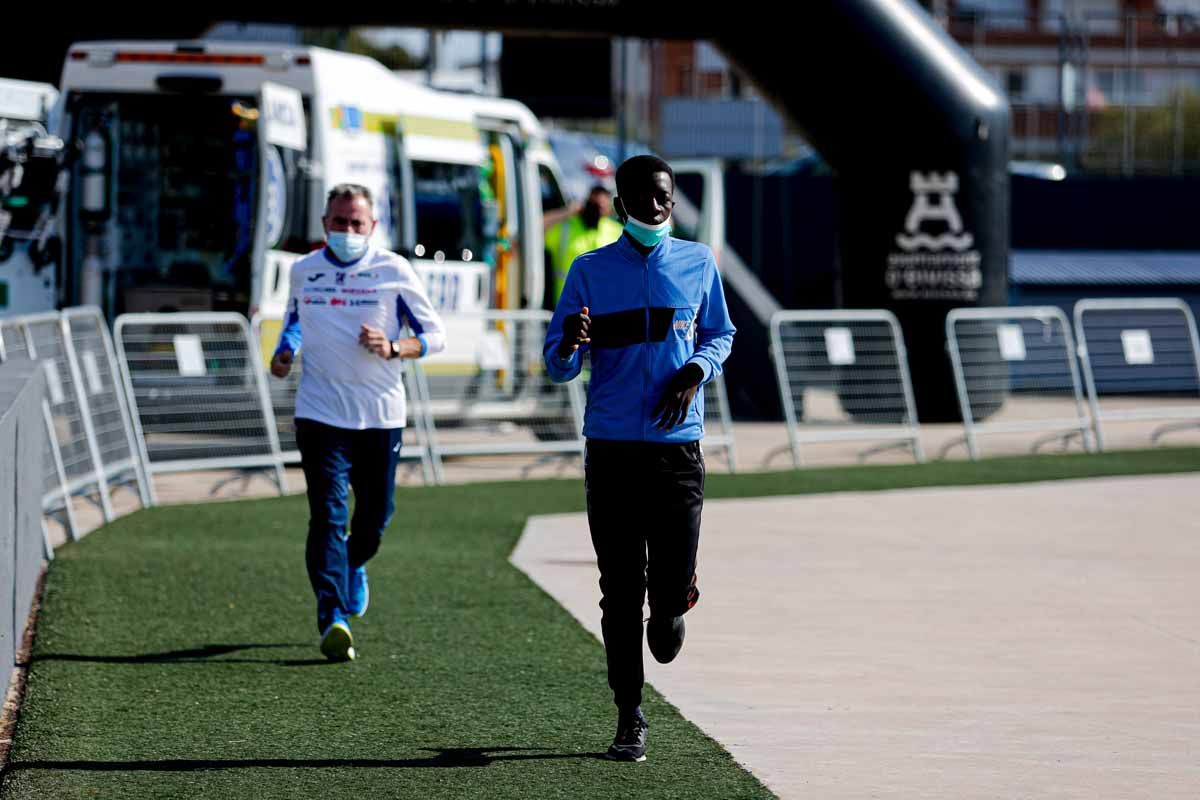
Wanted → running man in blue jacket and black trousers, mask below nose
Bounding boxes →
[544,156,734,760]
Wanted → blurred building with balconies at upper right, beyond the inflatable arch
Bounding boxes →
[931,0,1200,175]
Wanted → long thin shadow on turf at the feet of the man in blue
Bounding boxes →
[7,747,605,772]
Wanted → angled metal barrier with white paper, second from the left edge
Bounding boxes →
[18,312,115,533]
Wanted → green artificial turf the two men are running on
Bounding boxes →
[0,449,1200,800]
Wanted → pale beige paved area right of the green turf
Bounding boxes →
[512,475,1200,800]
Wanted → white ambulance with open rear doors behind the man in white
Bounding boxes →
[45,42,563,343]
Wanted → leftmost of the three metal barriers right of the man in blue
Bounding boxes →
[770,309,925,468]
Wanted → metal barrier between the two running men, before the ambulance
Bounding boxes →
[424,311,583,457]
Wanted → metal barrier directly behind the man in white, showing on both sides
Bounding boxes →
[251,314,442,483]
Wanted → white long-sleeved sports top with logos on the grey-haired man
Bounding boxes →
[276,247,445,431]
